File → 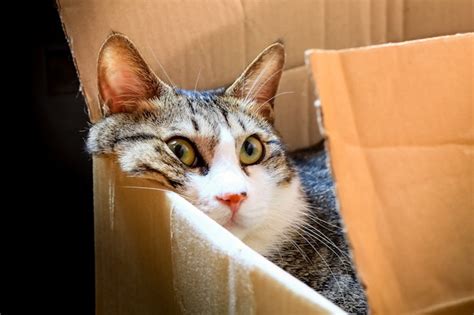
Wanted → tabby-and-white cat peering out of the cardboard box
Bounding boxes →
[87,33,366,313]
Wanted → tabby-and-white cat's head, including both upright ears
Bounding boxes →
[88,35,302,252]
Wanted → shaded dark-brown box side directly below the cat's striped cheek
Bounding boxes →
[94,162,179,314]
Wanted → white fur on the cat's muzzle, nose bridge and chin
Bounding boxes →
[188,128,305,254]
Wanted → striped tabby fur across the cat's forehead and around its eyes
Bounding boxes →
[87,90,295,188]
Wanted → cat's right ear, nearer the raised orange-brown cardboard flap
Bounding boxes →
[225,43,285,123]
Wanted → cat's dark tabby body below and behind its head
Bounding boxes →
[284,145,367,314]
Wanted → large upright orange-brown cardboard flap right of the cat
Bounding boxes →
[309,33,474,314]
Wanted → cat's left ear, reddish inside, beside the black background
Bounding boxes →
[97,33,171,115]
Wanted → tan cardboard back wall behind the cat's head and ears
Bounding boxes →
[58,0,474,149]
